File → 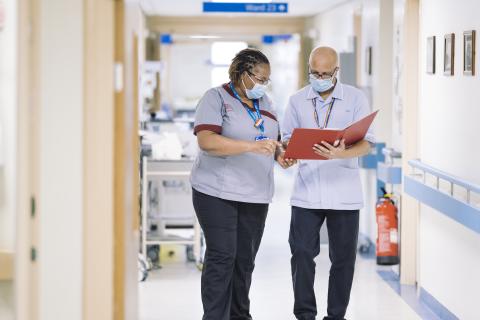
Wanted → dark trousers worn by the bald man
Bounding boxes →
[289,207,359,320]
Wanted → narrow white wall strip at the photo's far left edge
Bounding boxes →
[0,1,17,252]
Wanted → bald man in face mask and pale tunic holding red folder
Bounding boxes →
[282,47,375,320]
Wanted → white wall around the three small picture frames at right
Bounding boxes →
[419,0,480,319]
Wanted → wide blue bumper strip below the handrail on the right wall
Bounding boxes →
[404,176,480,233]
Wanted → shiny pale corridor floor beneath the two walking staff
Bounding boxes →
[139,172,432,320]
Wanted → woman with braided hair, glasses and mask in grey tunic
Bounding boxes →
[191,49,293,320]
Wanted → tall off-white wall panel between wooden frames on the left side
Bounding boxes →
[38,0,84,320]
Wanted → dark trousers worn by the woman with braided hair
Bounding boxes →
[193,189,268,320]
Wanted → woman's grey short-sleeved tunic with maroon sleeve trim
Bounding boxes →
[190,84,280,203]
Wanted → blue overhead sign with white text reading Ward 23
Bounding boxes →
[203,2,288,13]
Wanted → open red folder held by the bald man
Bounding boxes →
[285,110,378,160]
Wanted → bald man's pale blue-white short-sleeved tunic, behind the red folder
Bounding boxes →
[282,82,375,210]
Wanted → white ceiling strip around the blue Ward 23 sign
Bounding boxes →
[140,0,351,16]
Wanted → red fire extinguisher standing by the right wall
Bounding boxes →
[375,188,399,265]
